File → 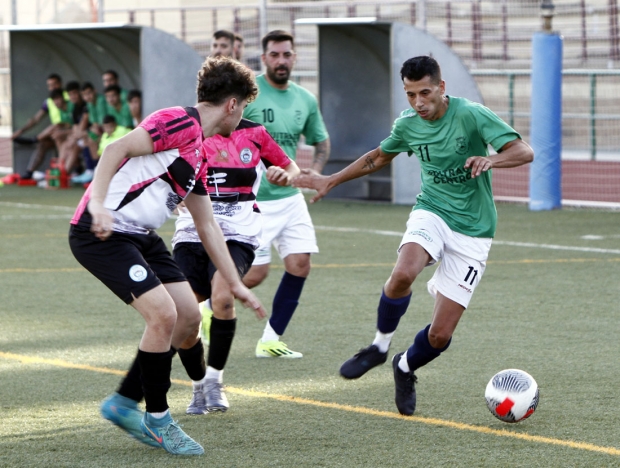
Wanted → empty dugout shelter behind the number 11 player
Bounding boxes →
[297,18,483,204]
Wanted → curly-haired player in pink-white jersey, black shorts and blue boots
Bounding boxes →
[69,58,265,455]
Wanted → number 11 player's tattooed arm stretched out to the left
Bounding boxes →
[293,147,398,203]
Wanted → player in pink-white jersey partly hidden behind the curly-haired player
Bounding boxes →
[172,119,300,414]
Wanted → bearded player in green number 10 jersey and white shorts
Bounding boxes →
[243,30,330,358]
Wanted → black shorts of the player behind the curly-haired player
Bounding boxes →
[172,241,254,298]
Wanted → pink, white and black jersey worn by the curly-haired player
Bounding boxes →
[71,107,207,234]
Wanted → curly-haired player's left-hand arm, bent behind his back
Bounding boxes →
[88,128,153,240]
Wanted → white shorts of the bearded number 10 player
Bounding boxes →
[252,193,319,265]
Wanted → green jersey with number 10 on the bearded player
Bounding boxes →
[243,75,329,201]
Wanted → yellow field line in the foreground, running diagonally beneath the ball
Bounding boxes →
[0,351,620,456]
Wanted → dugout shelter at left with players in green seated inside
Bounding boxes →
[6,23,203,172]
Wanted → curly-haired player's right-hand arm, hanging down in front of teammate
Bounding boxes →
[180,193,267,319]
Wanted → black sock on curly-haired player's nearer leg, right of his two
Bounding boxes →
[138,349,174,413]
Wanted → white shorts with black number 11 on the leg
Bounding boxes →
[398,210,493,308]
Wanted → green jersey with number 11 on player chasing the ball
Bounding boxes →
[381,96,521,237]
